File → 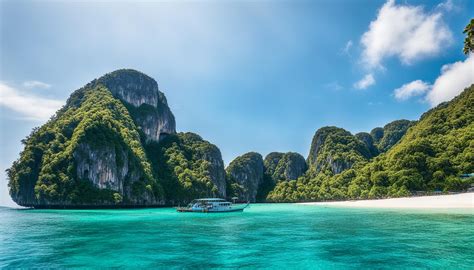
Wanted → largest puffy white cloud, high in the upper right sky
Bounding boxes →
[361,0,452,68]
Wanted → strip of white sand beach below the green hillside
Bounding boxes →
[302,192,474,209]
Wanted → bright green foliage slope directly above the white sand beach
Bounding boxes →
[268,85,474,202]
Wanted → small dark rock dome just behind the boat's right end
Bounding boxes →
[226,152,264,202]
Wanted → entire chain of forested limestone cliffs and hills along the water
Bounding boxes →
[7,69,474,208]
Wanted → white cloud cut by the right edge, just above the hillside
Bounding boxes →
[426,54,474,107]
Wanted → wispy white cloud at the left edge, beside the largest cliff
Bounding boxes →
[0,82,64,121]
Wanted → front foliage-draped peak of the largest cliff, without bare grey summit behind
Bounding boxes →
[8,84,164,207]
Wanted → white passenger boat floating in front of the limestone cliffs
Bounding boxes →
[176,198,250,213]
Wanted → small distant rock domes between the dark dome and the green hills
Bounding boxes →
[264,152,307,183]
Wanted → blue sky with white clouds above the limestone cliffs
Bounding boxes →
[0,0,474,206]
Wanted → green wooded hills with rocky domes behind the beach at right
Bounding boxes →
[266,84,474,202]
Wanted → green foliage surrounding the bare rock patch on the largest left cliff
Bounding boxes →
[8,86,162,204]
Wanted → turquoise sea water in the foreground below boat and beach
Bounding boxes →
[0,204,474,269]
